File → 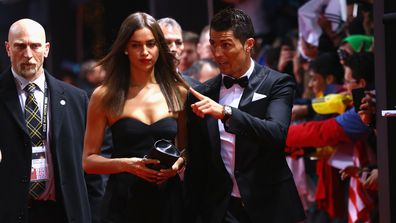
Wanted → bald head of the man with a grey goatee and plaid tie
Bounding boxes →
[5,19,50,81]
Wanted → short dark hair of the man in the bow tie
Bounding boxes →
[210,8,254,44]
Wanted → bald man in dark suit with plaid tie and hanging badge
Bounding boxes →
[0,19,91,223]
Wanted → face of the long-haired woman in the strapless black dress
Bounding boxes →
[125,28,159,72]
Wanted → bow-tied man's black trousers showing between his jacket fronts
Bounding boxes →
[223,197,252,223]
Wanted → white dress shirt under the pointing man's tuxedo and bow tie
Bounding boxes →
[218,59,254,197]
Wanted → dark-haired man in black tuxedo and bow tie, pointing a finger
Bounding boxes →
[185,9,305,223]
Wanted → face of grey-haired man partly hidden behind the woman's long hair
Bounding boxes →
[161,25,184,65]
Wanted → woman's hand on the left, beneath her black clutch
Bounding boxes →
[124,157,160,183]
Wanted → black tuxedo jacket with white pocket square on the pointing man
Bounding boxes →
[185,64,305,223]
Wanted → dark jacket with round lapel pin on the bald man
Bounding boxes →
[0,69,91,223]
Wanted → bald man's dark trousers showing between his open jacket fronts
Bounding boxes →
[28,200,67,223]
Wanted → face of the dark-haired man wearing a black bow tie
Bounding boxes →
[209,30,254,78]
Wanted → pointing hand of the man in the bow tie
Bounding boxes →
[190,88,224,119]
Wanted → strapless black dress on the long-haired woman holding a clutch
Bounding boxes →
[101,117,183,223]
